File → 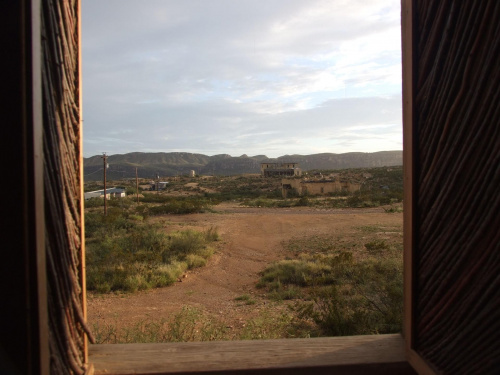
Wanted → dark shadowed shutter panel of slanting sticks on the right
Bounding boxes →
[413,0,500,374]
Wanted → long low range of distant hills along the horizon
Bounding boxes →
[83,151,403,181]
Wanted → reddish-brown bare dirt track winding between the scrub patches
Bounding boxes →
[87,203,402,336]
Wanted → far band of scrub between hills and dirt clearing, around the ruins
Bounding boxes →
[86,167,403,215]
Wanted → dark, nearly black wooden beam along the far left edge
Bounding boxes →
[0,0,50,374]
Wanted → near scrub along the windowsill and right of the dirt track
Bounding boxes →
[89,226,403,343]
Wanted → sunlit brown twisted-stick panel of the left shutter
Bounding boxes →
[41,0,92,374]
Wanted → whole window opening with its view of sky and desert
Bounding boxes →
[83,1,402,342]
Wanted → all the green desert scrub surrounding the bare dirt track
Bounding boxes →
[85,167,403,343]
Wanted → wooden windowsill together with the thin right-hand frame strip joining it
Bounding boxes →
[86,0,422,374]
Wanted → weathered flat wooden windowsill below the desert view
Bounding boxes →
[89,335,415,375]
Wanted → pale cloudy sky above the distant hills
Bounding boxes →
[82,0,402,157]
